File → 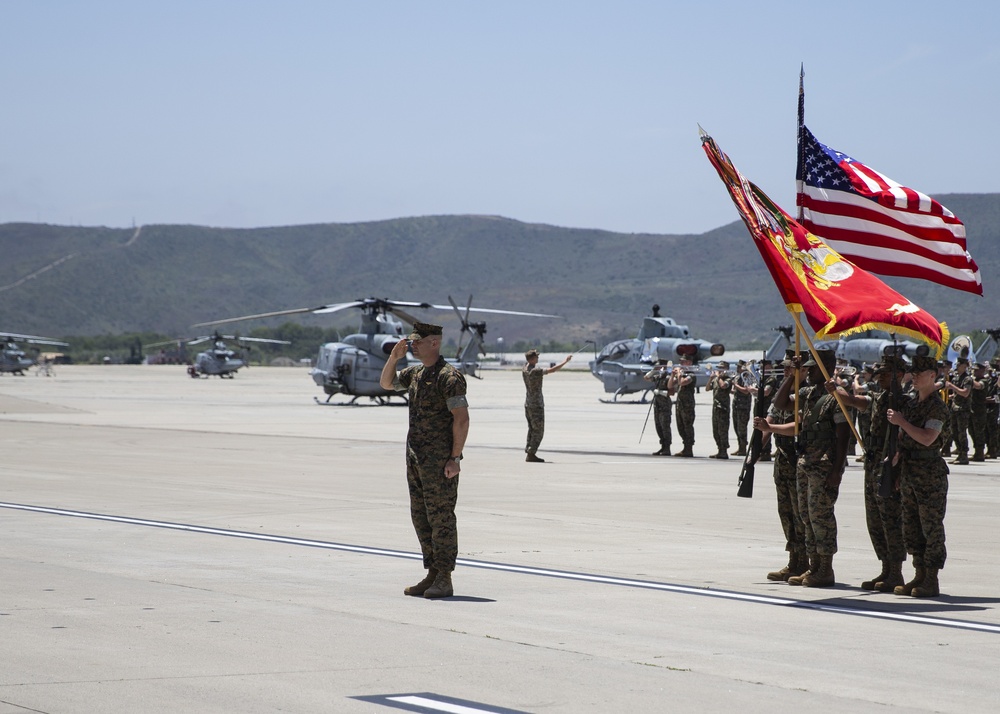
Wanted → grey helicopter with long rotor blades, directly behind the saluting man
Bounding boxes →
[195,296,556,404]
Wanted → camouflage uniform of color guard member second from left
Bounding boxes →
[795,385,847,558]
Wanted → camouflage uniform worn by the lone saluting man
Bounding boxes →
[396,357,468,573]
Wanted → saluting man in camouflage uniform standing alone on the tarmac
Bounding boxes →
[379,322,469,598]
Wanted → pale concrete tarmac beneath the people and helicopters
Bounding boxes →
[0,366,1000,714]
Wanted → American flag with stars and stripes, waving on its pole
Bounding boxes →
[796,126,983,295]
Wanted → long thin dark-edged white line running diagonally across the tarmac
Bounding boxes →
[7,501,1000,634]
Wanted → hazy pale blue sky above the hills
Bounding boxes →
[0,0,1000,233]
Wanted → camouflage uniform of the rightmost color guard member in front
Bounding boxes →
[899,392,948,569]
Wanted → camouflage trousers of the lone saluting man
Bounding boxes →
[406,451,459,573]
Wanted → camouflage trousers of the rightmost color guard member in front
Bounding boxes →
[900,458,948,569]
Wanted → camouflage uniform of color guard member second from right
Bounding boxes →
[861,389,906,563]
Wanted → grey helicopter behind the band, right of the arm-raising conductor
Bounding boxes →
[590,305,726,402]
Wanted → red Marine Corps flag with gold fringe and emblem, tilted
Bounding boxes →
[702,133,948,355]
